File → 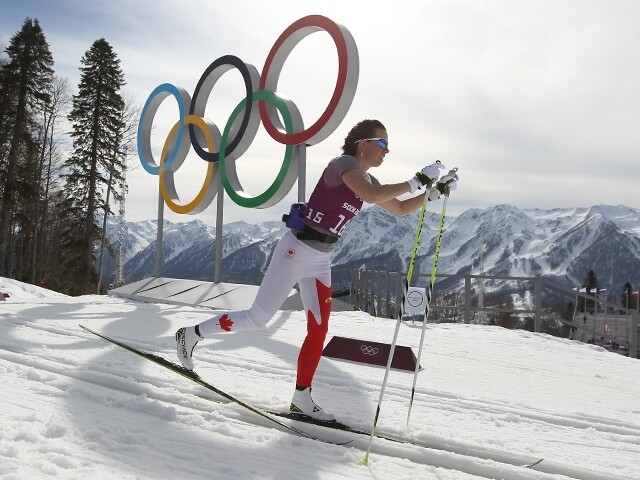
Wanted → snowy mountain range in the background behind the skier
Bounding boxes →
[105,205,640,294]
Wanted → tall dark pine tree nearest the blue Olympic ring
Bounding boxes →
[61,38,125,294]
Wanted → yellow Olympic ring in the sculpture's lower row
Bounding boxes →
[159,115,218,214]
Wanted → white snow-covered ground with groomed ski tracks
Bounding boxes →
[0,278,640,480]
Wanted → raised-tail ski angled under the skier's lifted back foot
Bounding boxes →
[78,325,351,445]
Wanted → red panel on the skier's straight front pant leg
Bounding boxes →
[296,280,331,387]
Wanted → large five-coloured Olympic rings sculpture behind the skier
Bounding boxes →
[137,15,359,214]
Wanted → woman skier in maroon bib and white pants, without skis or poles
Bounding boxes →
[176,120,453,422]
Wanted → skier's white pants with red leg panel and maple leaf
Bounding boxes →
[198,232,331,387]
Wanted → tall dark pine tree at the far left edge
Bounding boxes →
[0,18,53,276]
